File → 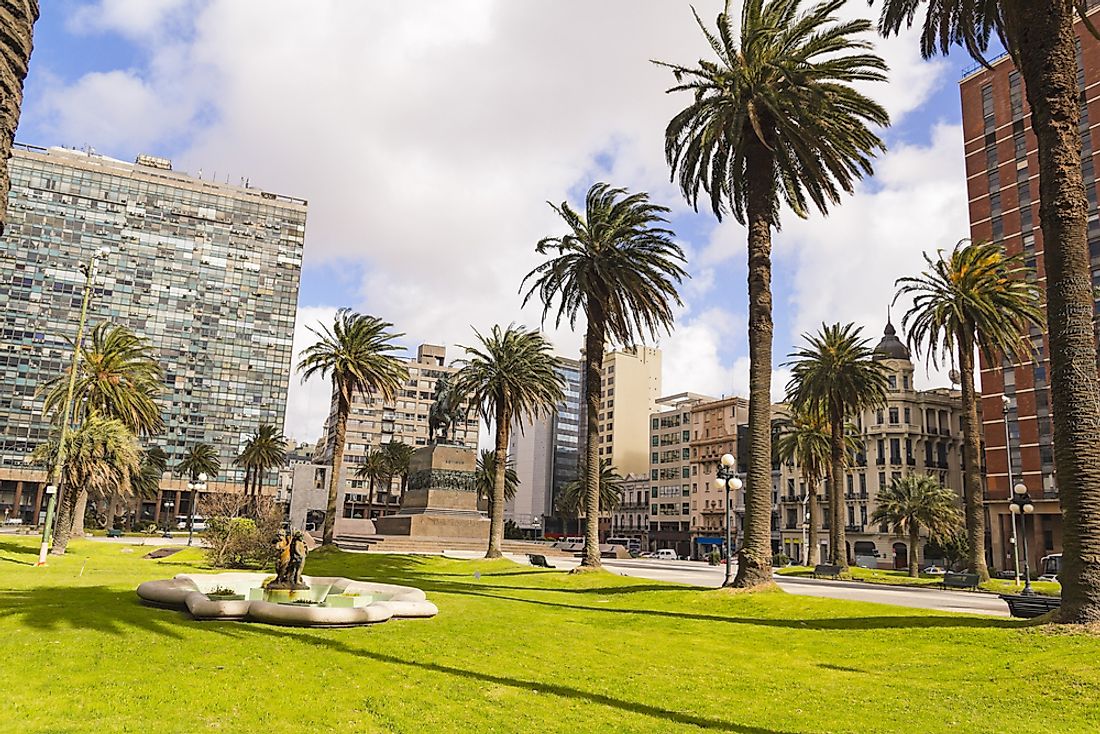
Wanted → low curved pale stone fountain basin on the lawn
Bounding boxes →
[138,573,439,627]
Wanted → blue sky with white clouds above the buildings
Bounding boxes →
[18,0,971,439]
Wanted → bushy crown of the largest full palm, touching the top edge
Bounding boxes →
[655,0,890,227]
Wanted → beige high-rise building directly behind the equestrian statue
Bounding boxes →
[308,344,480,534]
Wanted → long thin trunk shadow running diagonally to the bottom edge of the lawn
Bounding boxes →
[202,624,794,734]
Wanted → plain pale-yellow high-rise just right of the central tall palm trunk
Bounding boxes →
[598,347,661,476]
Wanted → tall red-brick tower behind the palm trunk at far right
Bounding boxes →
[944,7,1100,569]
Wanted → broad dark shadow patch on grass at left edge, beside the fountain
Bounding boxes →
[0,587,191,639]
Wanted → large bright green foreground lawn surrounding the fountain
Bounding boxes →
[0,537,1100,734]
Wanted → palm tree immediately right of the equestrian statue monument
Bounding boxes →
[454,326,565,558]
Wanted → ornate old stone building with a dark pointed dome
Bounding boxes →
[780,319,963,569]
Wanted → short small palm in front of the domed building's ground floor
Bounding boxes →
[871,474,963,579]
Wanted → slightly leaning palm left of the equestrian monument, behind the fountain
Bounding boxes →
[298,308,408,545]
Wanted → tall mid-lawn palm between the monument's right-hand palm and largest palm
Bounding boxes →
[524,184,688,568]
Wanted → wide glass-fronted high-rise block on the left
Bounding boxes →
[0,146,306,522]
